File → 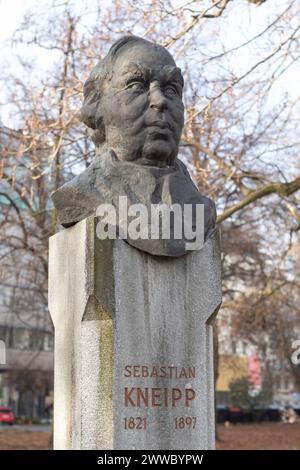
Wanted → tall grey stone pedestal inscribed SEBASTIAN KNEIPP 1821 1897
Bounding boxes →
[49,217,221,450]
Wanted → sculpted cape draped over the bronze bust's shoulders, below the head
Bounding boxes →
[52,150,216,256]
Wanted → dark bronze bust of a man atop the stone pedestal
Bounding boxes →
[52,36,216,256]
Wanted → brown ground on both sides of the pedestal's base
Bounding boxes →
[0,423,300,450]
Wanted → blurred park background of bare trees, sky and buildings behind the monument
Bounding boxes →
[0,0,300,449]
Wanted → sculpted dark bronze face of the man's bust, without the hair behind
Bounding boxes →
[101,43,184,165]
